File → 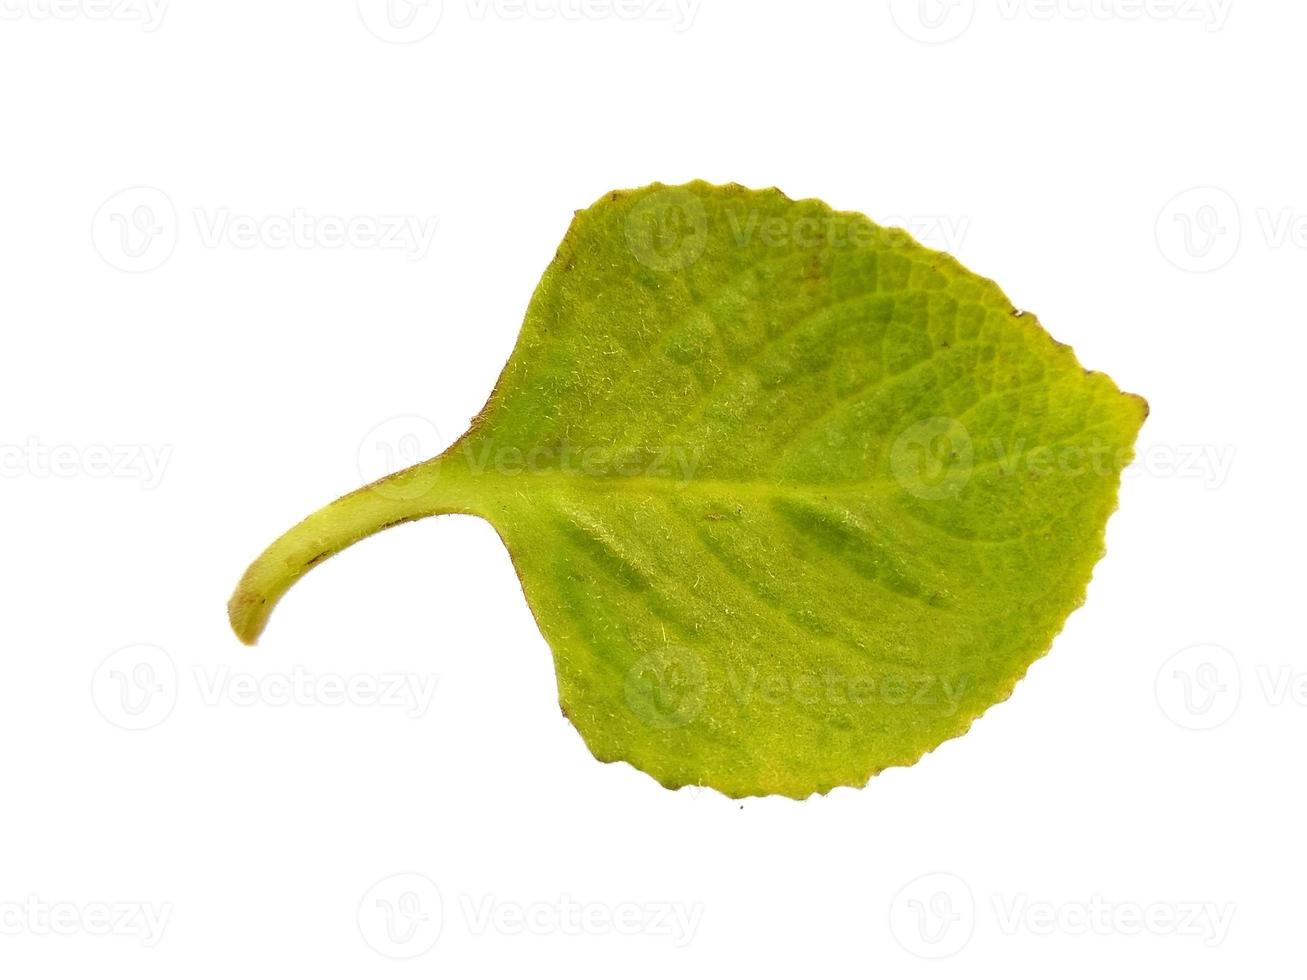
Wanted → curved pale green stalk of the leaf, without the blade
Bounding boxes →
[227,457,480,643]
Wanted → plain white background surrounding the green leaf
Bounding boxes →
[0,0,1307,979]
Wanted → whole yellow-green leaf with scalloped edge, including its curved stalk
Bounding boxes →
[230,183,1148,797]
